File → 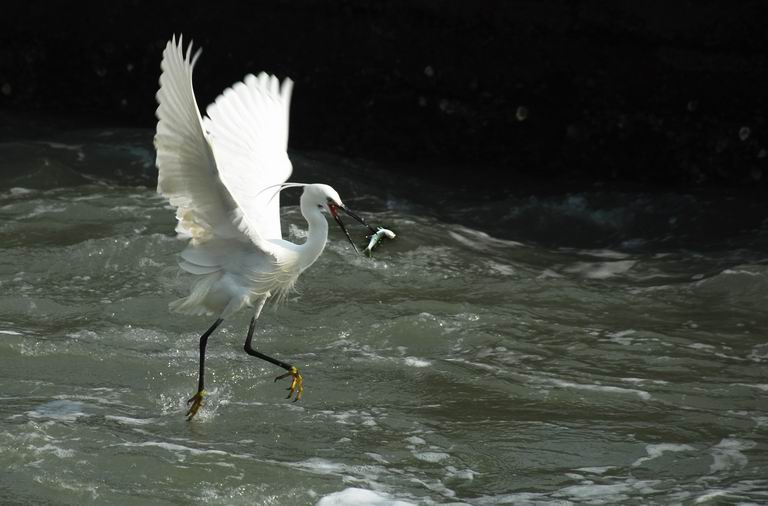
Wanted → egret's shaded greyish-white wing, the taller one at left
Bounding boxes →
[155,36,238,243]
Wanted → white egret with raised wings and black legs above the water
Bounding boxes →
[155,36,373,420]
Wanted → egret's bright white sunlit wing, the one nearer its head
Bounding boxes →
[203,73,293,244]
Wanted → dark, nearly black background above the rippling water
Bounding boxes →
[0,0,768,191]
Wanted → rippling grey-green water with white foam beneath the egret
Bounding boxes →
[0,124,768,506]
